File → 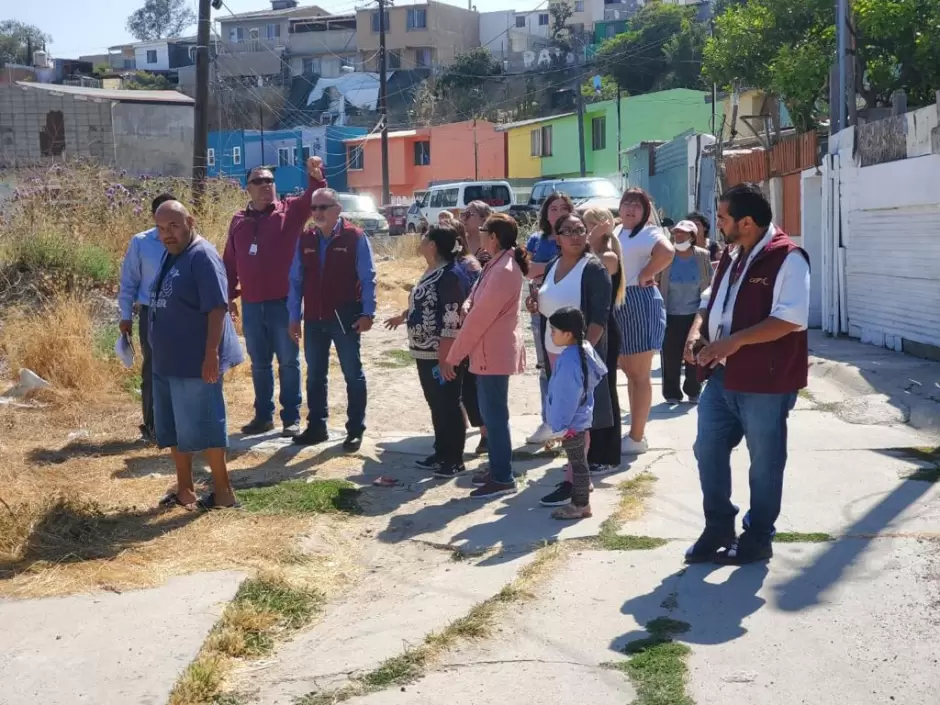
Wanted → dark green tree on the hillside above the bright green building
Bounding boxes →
[596,3,707,95]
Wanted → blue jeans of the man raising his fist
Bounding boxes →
[242,299,303,426]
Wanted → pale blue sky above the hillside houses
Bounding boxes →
[12,0,541,59]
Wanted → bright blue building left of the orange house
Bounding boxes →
[206,125,367,195]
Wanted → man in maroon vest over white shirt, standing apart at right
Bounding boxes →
[686,184,809,565]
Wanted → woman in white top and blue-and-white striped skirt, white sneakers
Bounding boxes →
[614,188,675,454]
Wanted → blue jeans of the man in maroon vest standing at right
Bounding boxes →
[695,367,796,542]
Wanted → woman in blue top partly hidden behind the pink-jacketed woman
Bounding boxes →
[526,191,574,444]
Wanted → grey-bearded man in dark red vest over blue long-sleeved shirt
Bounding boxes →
[287,188,375,452]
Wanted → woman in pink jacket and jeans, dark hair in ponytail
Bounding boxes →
[442,213,529,499]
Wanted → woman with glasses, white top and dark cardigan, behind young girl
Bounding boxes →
[527,209,614,507]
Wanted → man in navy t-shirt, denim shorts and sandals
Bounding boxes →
[150,201,243,509]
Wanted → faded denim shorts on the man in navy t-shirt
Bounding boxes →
[153,373,228,453]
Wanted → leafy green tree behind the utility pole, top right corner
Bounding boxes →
[703,0,940,130]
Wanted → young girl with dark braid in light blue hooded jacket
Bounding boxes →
[545,307,607,519]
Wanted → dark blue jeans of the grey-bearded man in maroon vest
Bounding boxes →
[304,321,366,435]
